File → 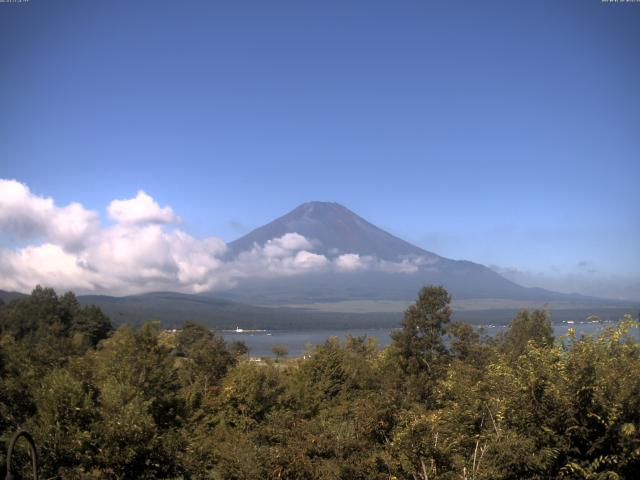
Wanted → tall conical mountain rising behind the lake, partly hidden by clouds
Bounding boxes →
[226,202,586,305]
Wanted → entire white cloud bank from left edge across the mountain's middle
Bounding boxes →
[0,179,421,295]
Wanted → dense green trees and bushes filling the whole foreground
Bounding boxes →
[0,287,640,480]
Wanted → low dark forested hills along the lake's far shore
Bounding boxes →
[0,290,639,330]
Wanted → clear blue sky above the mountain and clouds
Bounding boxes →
[0,0,640,294]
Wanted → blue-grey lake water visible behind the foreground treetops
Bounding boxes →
[220,322,637,357]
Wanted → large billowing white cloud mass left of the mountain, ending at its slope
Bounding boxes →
[0,180,225,294]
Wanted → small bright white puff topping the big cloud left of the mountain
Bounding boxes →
[107,190,180,225]
